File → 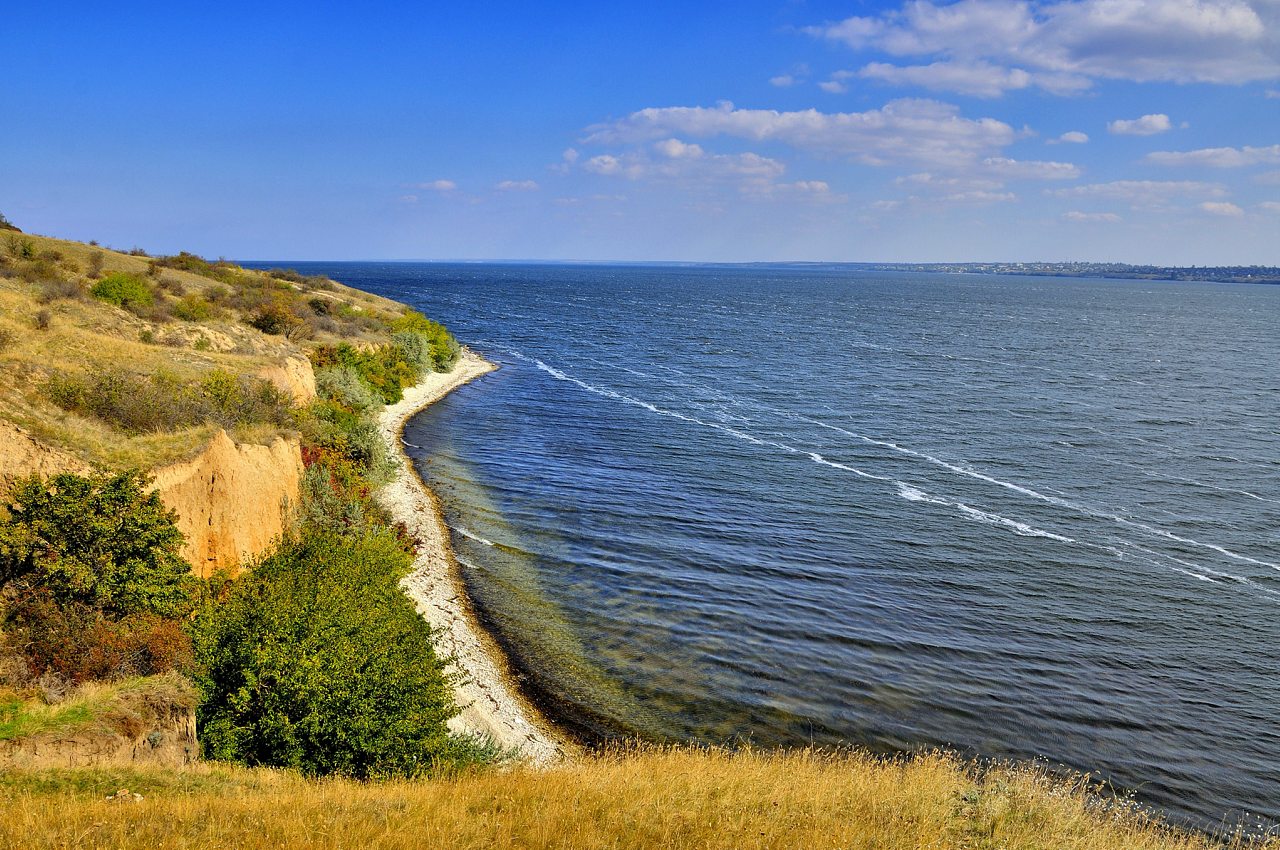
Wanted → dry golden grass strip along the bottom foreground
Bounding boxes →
[0,749,1264,850]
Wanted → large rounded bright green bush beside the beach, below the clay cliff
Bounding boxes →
[193,531,470,778]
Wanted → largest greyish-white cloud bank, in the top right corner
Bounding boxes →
[808,0,1280,96]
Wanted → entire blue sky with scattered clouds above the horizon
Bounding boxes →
[0,0,1280,265]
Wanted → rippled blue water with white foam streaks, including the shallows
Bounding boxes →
[262,264,1280,826]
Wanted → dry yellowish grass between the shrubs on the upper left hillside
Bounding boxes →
[0,233,403,469]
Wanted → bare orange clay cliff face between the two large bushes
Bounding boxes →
[155,431,302,576]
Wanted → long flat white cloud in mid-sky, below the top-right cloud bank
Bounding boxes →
[585,100,1016,166]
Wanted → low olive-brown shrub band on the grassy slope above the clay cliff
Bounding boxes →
[45,370,293,434]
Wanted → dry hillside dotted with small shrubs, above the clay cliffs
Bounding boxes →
[0,232,404,473]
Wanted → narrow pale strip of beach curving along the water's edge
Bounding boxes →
[378,348,568,763]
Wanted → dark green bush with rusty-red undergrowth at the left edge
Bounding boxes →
[0,471,200,681]
